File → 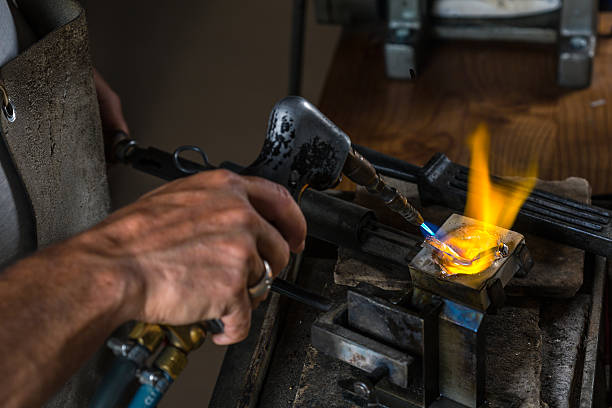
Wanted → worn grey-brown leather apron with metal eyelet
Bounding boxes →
[0,0,110,408]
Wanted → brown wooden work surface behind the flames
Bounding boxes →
[320,14,612,194]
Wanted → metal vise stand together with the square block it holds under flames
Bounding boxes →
[311,214,533,407]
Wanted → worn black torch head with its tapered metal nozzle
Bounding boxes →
[241,96,423,227]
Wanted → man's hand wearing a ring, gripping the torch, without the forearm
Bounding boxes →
[78,170,306,344]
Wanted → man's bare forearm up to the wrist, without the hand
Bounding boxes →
[0,239,135,407]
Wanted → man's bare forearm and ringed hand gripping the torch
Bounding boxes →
[0,170,306,407]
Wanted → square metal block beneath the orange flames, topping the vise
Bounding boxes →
[410,214,533,312]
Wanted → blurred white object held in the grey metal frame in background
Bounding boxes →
[433,0,560,18]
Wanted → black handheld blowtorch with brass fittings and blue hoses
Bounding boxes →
[90,97,469,408]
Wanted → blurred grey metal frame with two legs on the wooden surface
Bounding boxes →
[315,0,598,88]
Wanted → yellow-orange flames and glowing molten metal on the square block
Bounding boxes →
[436,125,537,275]
